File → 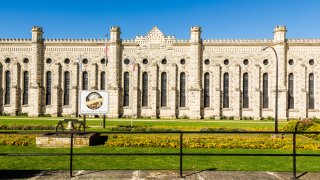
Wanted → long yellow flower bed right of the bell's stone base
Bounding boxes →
[105,134,320,150]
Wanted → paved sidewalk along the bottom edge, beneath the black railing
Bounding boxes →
[0,170,320,180]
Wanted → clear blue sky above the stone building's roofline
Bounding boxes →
[0,0,320,39]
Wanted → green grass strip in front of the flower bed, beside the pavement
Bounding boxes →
[0,146,320,172]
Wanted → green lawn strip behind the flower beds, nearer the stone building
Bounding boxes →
[0,116,287,131]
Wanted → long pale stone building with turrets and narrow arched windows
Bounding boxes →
[0,26,320,119]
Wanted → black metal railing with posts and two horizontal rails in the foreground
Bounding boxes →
[0,127,320,179]
